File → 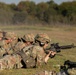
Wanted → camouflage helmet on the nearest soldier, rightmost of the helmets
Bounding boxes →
[35,33,51,43]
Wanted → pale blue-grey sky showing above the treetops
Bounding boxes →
[0,0,73,4]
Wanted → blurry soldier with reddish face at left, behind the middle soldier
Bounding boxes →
[0,32,17,56]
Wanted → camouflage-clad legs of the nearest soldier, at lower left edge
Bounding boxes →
[0,33,35,69]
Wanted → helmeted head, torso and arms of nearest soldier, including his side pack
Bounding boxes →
[19,33,54,68]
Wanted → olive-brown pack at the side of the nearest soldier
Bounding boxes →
[18,45,36,68]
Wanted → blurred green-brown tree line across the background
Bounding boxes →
[0,0,76,25]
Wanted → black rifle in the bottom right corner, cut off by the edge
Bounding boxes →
[57,60,76,75]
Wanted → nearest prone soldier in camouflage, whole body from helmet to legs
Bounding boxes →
[0,34,56,69]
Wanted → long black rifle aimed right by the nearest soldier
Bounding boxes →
[45,43,76,58]
